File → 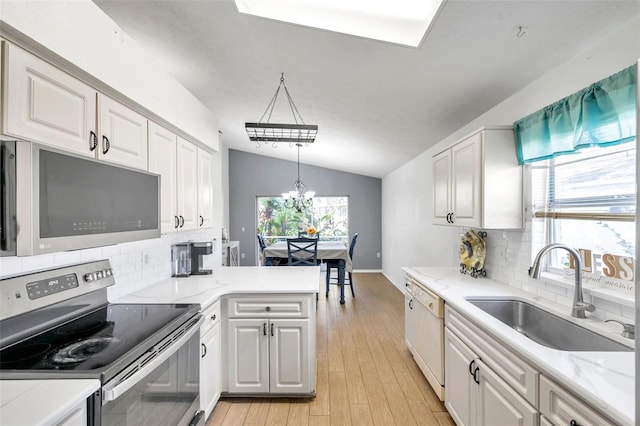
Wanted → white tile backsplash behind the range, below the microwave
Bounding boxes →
[0,229,220,300]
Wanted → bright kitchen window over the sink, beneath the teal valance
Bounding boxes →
[530,141,636,272]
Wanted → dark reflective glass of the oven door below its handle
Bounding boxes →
[101,333,200,426]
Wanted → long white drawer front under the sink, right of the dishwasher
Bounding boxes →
[445,305,538,407]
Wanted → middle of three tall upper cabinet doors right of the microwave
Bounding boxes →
[176,137,198,231]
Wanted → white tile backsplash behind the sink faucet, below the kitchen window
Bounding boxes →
[478,220,635,323]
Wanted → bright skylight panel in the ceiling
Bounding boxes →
[235,0,445,47]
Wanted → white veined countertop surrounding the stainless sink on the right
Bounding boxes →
[402,267,635,425]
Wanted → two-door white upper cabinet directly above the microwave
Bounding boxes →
[2,42,147,170]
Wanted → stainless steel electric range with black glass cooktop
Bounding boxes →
[0,260,204,426]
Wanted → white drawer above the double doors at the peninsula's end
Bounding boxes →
[227,294,313,318]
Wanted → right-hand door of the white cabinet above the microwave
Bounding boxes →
[98,94,148,170]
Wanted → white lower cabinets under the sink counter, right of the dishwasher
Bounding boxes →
[444,304,616,426]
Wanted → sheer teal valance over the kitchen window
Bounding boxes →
[514,65,637,164]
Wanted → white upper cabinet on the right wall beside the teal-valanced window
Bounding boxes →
[432,127,524,229]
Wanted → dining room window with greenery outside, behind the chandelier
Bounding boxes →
[256,196,349,245]
